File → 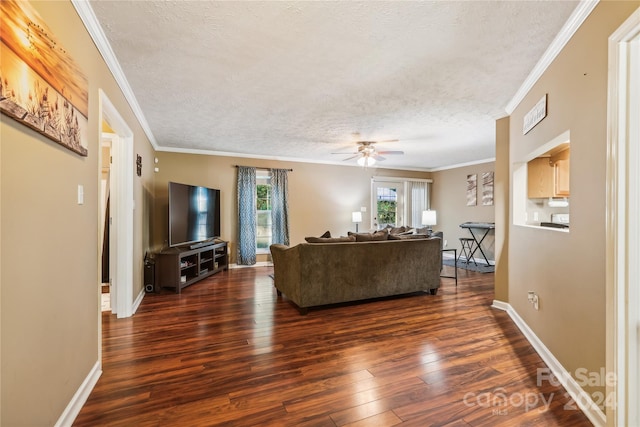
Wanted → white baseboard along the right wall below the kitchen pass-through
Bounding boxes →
[491,300,607,427]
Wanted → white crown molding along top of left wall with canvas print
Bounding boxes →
[71,0,158,150]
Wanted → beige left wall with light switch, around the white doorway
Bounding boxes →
[0,1,153,426]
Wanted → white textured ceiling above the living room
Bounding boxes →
[85,0,579,170]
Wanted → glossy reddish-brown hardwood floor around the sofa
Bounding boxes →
[74,267,591,427]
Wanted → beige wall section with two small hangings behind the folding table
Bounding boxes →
[431,162,496,261]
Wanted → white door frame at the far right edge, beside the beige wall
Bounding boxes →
[605,8,640,426]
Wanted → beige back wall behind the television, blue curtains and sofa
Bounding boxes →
[153,152,430,263]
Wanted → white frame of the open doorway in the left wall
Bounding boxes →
[98,89,134,322]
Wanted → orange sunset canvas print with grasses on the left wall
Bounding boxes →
[0,0,89,156]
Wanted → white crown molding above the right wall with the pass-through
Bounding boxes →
[505,0,600,115]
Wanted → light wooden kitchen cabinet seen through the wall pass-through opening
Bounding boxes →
[527,148,570,199]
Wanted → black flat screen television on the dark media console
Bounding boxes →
[169,182,220,247]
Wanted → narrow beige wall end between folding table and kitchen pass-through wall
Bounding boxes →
[493,117,510,302]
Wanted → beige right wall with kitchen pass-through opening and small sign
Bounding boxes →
[508,1,638,400]
